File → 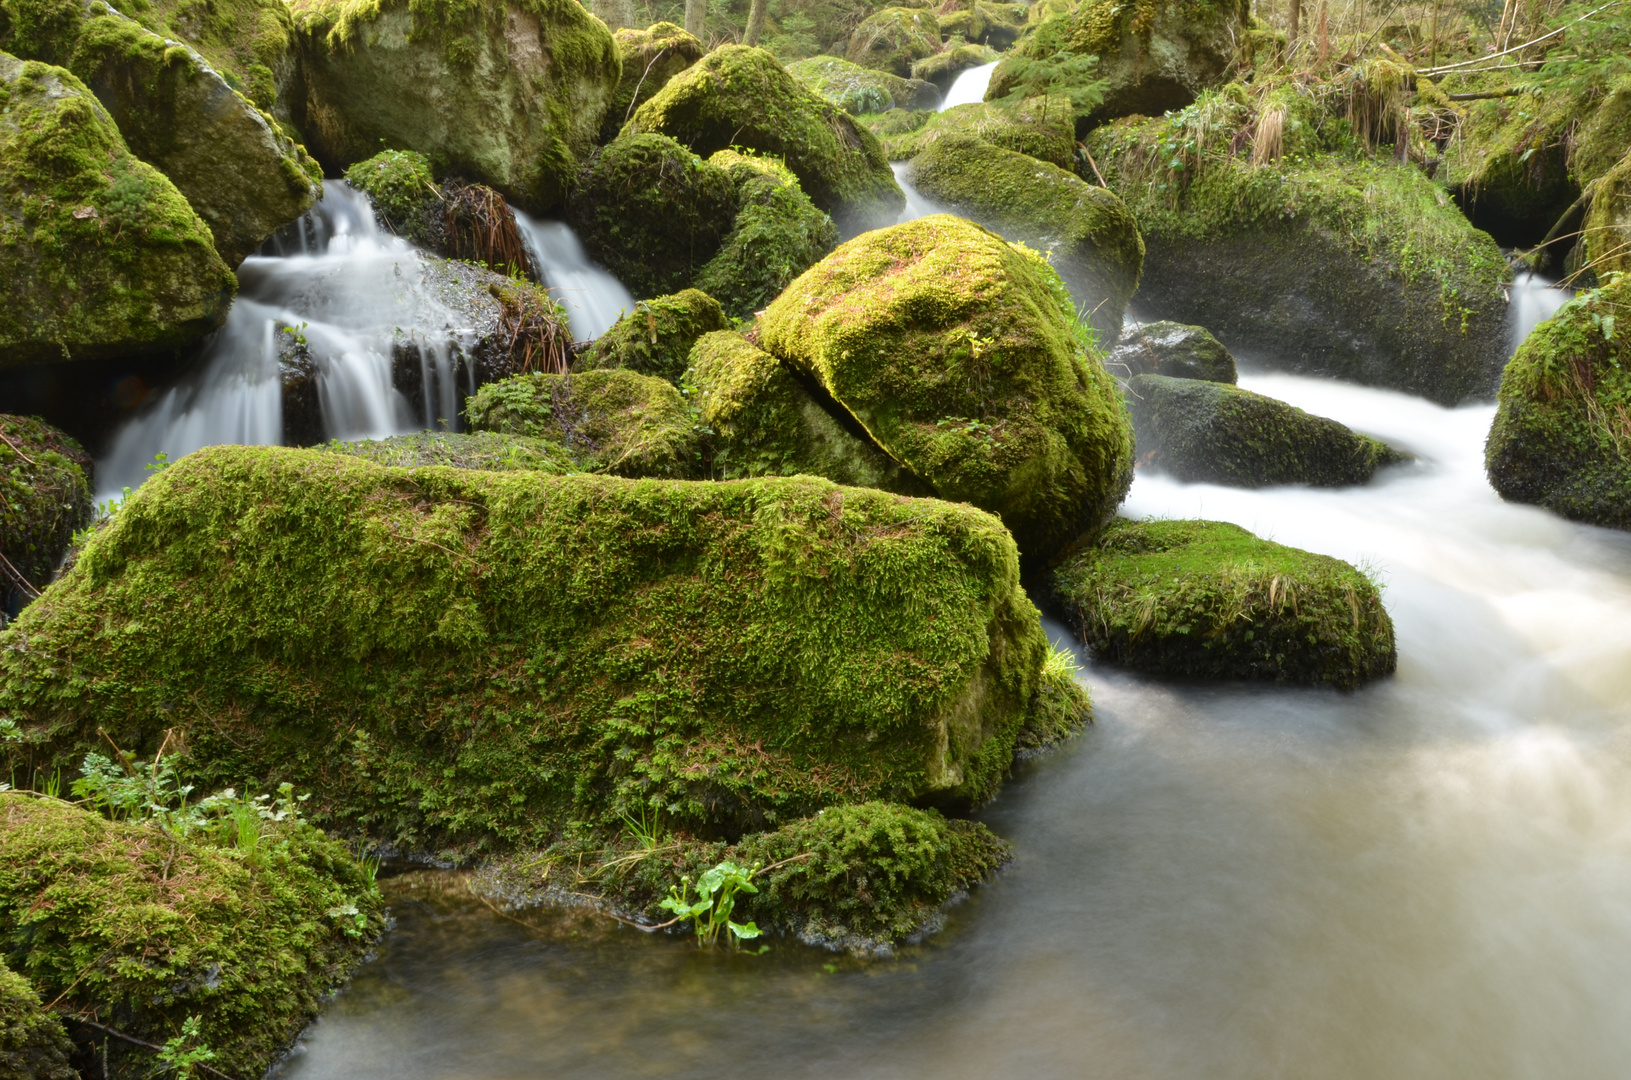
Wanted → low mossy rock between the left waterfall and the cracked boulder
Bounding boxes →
[465,367,701,478]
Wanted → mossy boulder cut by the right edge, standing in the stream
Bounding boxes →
[1484,277,1631,529]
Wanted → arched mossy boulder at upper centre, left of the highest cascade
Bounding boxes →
[630,46,905,233]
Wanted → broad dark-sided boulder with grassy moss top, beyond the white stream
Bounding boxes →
[1088,110,1509,405]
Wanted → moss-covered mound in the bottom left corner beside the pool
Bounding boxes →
[0,793,383,1078]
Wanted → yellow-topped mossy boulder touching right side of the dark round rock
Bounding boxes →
[696,150,838,320]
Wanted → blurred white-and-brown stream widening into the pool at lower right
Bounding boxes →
[282,281,1631,1080]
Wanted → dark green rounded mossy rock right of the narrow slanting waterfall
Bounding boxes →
[566,134,736,297]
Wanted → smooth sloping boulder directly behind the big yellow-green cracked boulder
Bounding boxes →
[908,135,1143,341]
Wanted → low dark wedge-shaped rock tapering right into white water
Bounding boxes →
[1127,375,1409,488]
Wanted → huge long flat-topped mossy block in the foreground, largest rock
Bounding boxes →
[0,447,1049,854]
